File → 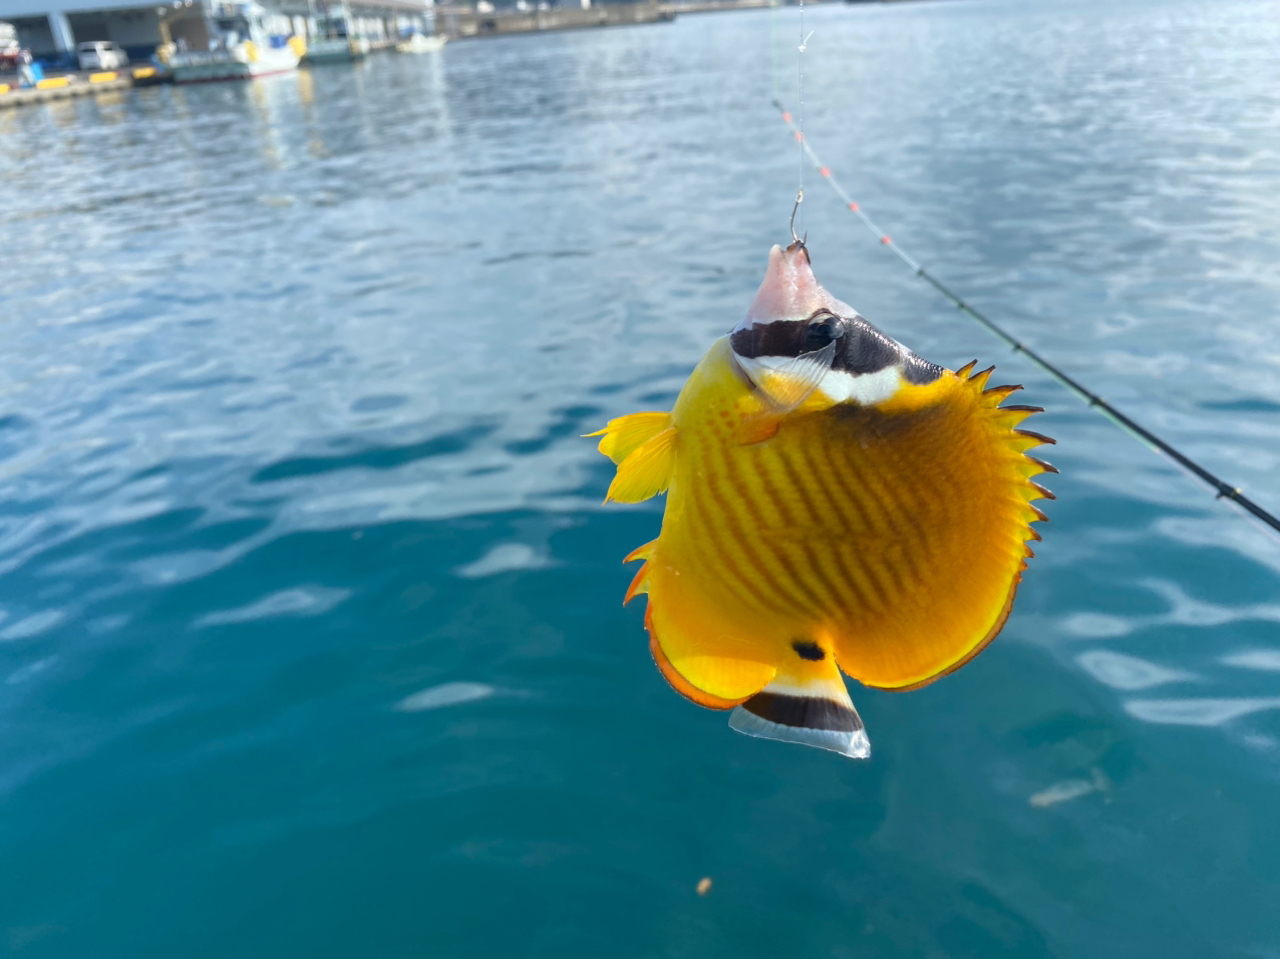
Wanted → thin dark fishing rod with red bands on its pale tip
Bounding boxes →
[773,103,1280,533]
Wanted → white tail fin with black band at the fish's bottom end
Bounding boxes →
[728,644,872,759]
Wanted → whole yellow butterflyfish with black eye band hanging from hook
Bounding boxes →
[590,242,1056,758]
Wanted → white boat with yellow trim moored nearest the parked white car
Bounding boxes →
[166,3,306,83]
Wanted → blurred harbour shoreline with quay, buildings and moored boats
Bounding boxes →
[0,0,865,108]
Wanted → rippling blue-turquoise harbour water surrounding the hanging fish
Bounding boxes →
[0,0,1280,959]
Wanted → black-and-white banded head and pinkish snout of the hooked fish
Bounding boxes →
[730,245,942,406]
